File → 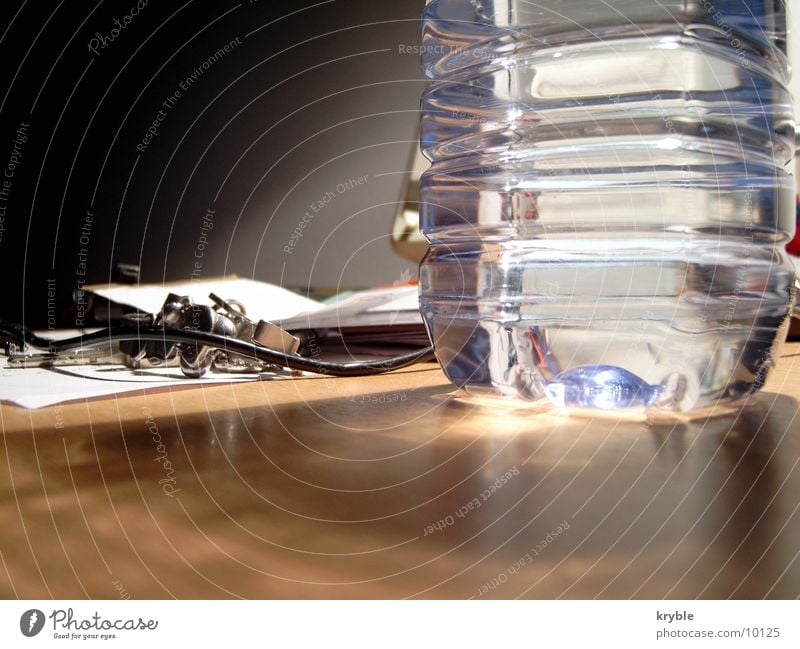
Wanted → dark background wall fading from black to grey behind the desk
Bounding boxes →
[0,0,424,327]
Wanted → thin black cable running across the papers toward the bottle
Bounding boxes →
[0,321,435,376]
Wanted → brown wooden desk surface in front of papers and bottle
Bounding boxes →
[0,344,800,598]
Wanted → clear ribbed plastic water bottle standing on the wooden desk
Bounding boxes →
[420,0,795,411]
